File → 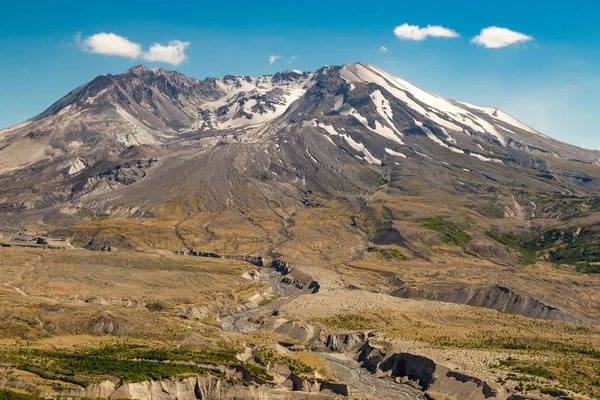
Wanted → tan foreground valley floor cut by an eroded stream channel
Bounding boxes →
[0,248,600,399]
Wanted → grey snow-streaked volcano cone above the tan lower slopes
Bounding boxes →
[0,63,600,219]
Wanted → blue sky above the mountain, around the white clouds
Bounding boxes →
[0,0,600,149]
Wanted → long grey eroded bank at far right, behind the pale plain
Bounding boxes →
[390,285,591,323]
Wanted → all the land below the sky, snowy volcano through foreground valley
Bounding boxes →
[0,63,600,400]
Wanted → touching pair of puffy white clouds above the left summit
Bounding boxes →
[75,32,190,65]
